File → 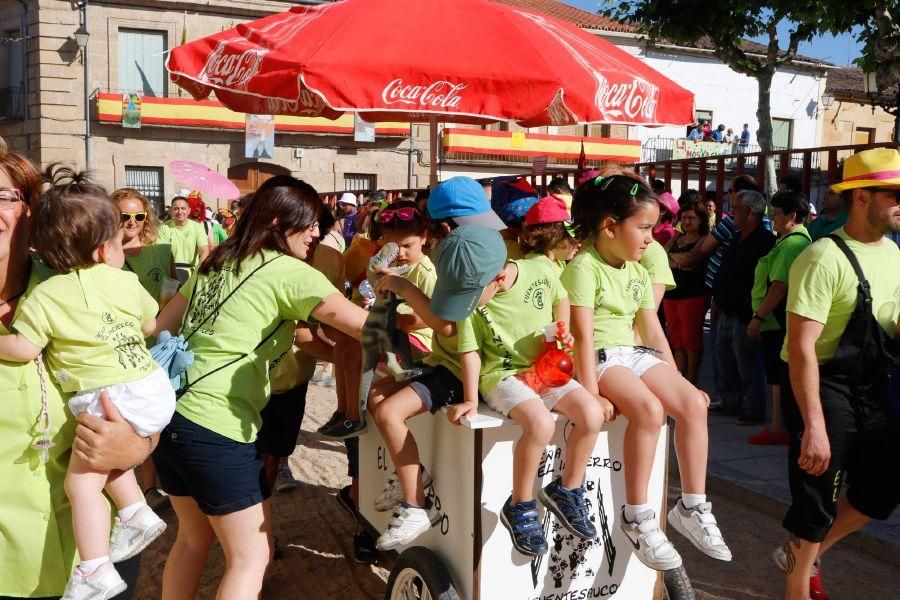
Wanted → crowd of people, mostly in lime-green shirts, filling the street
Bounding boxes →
[0,144,900,600]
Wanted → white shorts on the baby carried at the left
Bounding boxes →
[69,368,175,437]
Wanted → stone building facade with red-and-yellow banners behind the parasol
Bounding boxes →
[0,0,639,211]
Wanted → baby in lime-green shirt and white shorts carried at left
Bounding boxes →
[0,170,175,600]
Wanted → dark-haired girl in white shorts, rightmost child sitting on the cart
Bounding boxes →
[562,174,731,570]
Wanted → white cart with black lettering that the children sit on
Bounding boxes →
[359,404,689,600]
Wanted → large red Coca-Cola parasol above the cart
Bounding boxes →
[168,0,694,127]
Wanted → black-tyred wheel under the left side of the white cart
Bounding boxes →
[384,546,459,600]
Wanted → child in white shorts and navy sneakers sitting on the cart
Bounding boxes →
[457,251,613,556]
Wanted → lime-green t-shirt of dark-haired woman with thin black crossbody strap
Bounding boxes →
[176,250,338,442]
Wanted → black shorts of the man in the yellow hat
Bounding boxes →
[781,363,900,542]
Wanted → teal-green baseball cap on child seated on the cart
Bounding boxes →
[431,225,506,322]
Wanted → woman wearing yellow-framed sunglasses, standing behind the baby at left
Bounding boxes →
[111,188,178,306]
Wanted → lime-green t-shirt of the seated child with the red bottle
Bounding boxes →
[456,256,566,396]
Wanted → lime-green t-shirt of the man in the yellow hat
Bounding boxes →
[781,227,900,364]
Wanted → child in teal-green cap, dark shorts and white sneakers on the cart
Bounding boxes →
[369,226,506,550]
